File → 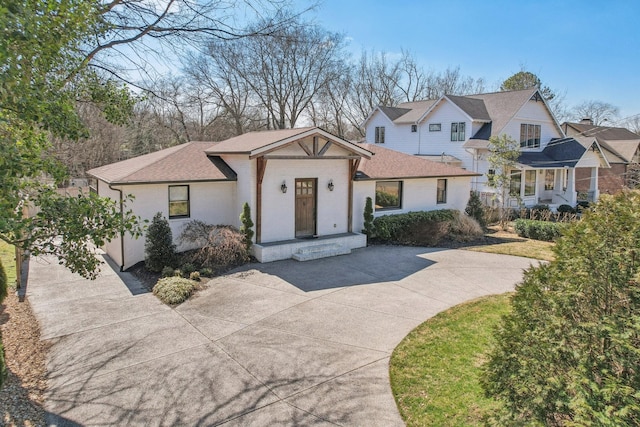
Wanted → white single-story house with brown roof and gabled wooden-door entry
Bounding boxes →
[88,127,477,269]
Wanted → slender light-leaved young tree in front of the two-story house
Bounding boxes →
[487,134,520,229]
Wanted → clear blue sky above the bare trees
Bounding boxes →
[298,0,640,117]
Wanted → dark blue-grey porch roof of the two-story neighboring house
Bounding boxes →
[518,138,587,169]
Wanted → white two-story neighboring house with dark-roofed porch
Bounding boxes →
[364,88,608,207]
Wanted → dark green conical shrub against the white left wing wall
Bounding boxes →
[144,212,176,273]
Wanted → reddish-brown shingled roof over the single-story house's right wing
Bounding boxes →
[356,144,479,180]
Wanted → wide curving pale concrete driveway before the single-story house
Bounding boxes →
[27,246,532,426]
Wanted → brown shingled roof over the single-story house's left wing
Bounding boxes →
[87,142,236,184]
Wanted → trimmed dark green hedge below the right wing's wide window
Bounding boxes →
[373,209,459,246]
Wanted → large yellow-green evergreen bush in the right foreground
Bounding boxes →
[482,191,640,426]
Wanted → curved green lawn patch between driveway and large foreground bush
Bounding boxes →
[389,294,510,426]
